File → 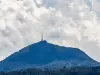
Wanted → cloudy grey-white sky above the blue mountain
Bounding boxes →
[0,0,100,62]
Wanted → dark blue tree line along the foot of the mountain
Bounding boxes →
[0,67,100,75]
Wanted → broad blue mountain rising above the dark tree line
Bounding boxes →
[0,40,99,71]
